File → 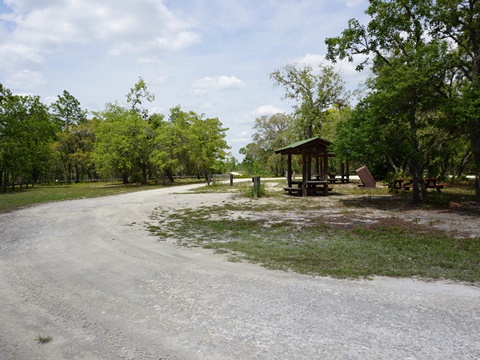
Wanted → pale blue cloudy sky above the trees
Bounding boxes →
[0,0,367,158]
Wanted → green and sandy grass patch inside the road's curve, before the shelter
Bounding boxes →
[148,181,480,283]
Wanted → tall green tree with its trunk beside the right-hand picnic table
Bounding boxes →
[326,0,449,203]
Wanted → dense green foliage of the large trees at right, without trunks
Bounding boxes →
[325,0,480,202]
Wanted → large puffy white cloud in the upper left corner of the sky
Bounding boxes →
[3,0,200,54]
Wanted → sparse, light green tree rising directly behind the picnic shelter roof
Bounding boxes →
[270,64,348,138]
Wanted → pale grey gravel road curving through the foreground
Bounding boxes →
[0,187,480,360]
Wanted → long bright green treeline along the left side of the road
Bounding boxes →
[0,78,235,192]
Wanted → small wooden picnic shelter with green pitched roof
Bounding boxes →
[275,137,335,196]
